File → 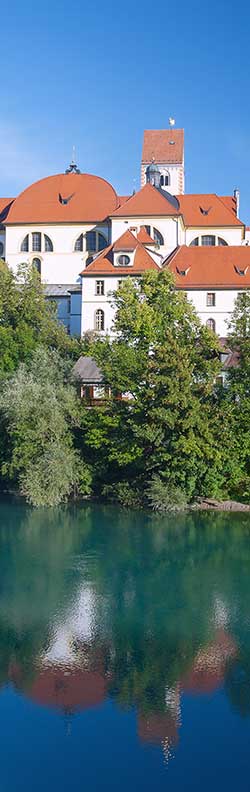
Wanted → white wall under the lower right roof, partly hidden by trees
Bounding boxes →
[186,287,242,337]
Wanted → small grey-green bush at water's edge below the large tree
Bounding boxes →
[145,474,187,512]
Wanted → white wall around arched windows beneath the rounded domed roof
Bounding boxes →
[5,223,108,283]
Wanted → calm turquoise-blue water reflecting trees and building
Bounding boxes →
[0,501,250,792]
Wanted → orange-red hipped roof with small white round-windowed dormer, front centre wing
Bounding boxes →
[80,231,159,277]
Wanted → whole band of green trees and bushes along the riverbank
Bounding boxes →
[0,264,250,511]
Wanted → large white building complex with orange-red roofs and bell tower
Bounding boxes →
[0,129,250,336]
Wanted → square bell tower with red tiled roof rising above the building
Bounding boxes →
[141,118,184,195]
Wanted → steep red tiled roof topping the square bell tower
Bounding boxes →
[142,129,184,163]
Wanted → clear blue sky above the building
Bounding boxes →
[0,0,250,224]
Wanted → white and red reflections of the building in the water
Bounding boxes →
[5,587,237,761]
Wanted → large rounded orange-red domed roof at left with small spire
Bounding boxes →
[7,173,119,224]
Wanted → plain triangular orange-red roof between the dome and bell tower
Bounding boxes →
[113,184,178,217]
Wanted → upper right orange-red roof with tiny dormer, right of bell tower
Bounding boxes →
[177,193,244,228]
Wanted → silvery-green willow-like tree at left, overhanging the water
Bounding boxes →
[0,347,91,506]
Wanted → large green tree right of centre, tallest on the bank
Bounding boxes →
[82,270,221,499]
